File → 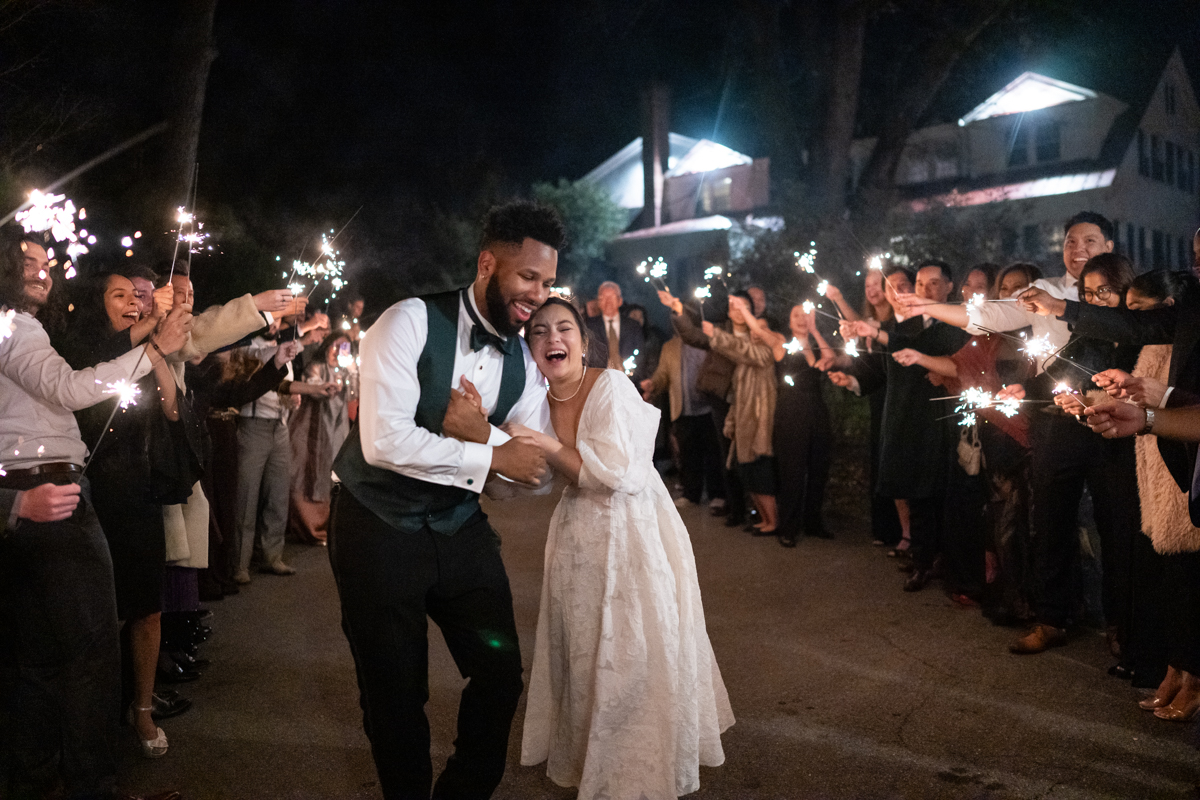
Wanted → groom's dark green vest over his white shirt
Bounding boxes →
[334,290,526,535]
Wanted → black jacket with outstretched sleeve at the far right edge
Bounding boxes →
[1060,293,1200,492]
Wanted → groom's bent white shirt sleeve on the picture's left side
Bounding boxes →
[359,299,508,492]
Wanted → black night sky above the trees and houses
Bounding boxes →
[0,0,1200,293]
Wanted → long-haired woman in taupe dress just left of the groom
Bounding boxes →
[288,331,356,546]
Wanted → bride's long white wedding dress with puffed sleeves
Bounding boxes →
[521,369,733,800]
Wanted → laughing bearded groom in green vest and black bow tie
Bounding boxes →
[329,201,564,800]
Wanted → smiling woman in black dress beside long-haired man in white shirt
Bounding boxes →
[58,273,187,758]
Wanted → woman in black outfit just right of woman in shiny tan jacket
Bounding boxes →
[769,306,833,547]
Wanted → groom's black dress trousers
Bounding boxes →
[329,487,523,800]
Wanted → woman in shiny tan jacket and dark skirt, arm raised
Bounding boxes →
[701,293,778,536]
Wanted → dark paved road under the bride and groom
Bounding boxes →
[122,498,1200,800]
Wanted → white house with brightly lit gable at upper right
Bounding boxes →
[852,49,1200,270]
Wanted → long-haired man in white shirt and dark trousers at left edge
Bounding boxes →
[0,237,190,798]
